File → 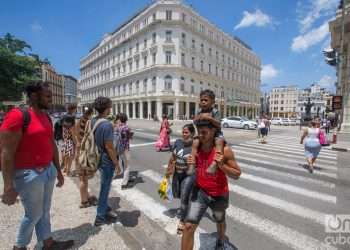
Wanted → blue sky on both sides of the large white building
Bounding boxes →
[0,0,339,94]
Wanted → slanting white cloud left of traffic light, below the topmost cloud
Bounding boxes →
[291,20,329,52]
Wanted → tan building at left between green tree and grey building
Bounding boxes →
[41,63,64,109]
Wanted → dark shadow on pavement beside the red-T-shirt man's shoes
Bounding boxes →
[34,223,101,250]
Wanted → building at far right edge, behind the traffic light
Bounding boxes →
[329,0,350,132]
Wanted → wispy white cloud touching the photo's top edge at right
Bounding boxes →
[297,0,339,33]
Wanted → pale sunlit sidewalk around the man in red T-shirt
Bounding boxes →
[0,177,129,250]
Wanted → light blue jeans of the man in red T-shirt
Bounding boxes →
[14,163,57,247]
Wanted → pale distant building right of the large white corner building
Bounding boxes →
[270,86,299,118]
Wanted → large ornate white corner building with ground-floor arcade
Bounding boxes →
[79,0,261,119]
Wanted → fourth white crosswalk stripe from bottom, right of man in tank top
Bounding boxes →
[239,162,335,189]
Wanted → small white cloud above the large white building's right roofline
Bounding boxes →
[235,9,272,30]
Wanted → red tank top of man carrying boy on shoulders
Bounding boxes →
[196,148,229,196]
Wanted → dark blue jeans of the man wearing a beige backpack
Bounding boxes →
[97,163,114,218]
